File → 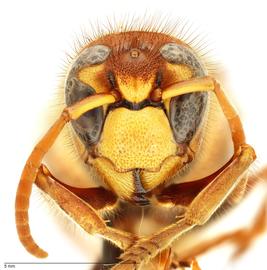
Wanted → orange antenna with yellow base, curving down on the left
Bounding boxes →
[15,94,116,258]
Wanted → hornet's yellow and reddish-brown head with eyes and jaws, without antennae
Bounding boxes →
[66,32,207,205]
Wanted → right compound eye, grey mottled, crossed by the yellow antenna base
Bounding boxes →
[160,43,208,143]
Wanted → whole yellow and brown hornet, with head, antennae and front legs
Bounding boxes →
[16,23,267,270]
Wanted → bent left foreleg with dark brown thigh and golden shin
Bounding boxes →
[38,165,140,270]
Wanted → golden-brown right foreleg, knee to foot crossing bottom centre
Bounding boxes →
[113,145,255,270]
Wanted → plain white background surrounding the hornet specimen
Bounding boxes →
[0,0,267,270]
